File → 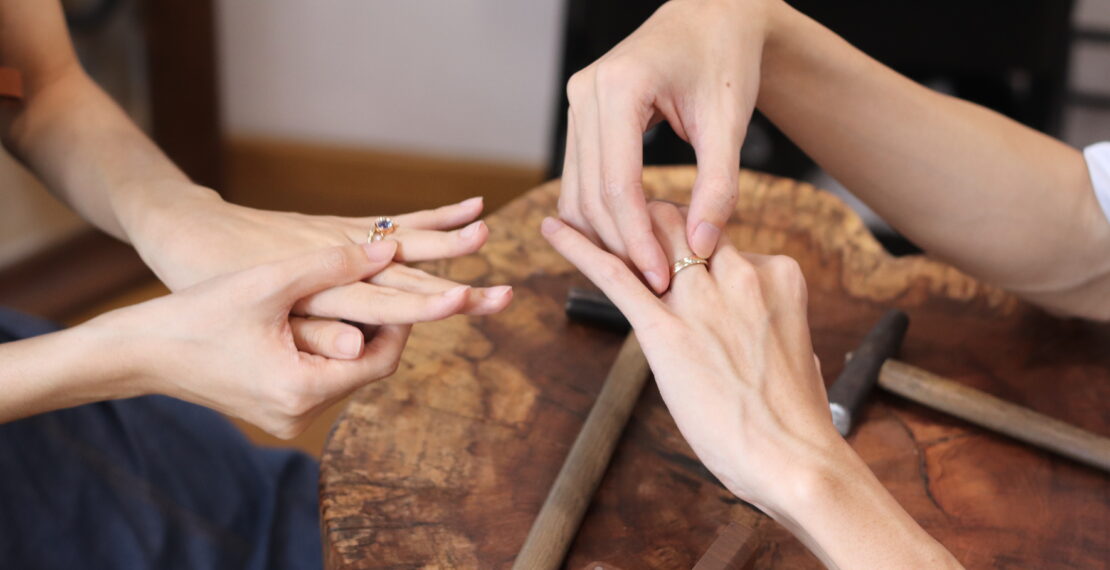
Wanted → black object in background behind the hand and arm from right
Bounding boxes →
[547,0,1074,254]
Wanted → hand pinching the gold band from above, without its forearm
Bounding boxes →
[559,0,766,293]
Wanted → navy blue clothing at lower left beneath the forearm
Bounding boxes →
[0,309,322,570]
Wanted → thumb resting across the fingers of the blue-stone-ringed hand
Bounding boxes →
[263,240,397,306]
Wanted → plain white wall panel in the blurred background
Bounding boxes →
[218,0,563,165]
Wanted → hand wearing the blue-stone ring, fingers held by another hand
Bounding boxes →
[135,195,513,358]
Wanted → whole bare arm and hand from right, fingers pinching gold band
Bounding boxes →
[559,0,1110,319]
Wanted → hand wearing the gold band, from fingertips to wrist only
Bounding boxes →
[543,202,840,512]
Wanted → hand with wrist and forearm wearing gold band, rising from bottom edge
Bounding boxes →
[542,203,959,568]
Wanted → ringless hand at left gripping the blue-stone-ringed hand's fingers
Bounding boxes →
[89,242,417,438]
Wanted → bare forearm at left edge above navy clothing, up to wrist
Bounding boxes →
[0,320,141,423]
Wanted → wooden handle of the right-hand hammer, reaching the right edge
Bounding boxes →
[879,359,1110,471]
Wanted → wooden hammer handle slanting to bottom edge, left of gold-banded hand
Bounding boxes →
[513,334,650,570]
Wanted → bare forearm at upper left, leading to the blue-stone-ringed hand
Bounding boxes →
[0,0,216,252]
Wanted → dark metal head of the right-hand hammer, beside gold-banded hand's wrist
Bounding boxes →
[829,308,909,437]
